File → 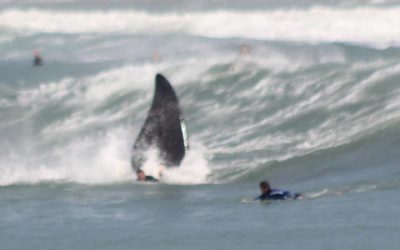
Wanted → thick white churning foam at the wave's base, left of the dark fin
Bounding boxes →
[0,128,134,186]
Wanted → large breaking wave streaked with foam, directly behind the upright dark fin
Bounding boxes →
[0,51,400,185]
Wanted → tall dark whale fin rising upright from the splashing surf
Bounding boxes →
[131,74,189,170]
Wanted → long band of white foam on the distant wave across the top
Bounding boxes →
[0,6,400,46]
